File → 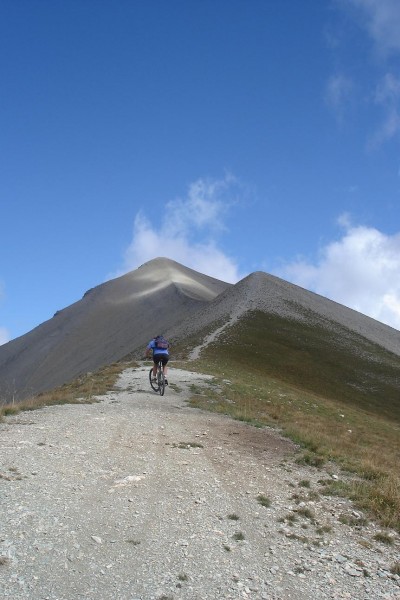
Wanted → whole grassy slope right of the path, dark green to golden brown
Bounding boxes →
[180,311,400,528]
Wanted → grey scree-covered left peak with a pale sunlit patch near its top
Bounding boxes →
[0,258,230,403]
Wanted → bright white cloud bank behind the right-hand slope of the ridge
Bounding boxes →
[277,217,400,329]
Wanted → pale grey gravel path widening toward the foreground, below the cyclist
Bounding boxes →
[0,367,400,600]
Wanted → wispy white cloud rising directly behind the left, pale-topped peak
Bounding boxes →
[119,175,241,283]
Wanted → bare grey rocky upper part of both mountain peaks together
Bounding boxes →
[0,258,400,403]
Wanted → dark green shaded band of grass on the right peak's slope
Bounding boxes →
[212,311,400,424]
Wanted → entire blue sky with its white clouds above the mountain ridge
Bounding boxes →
[0,0,400,343]
